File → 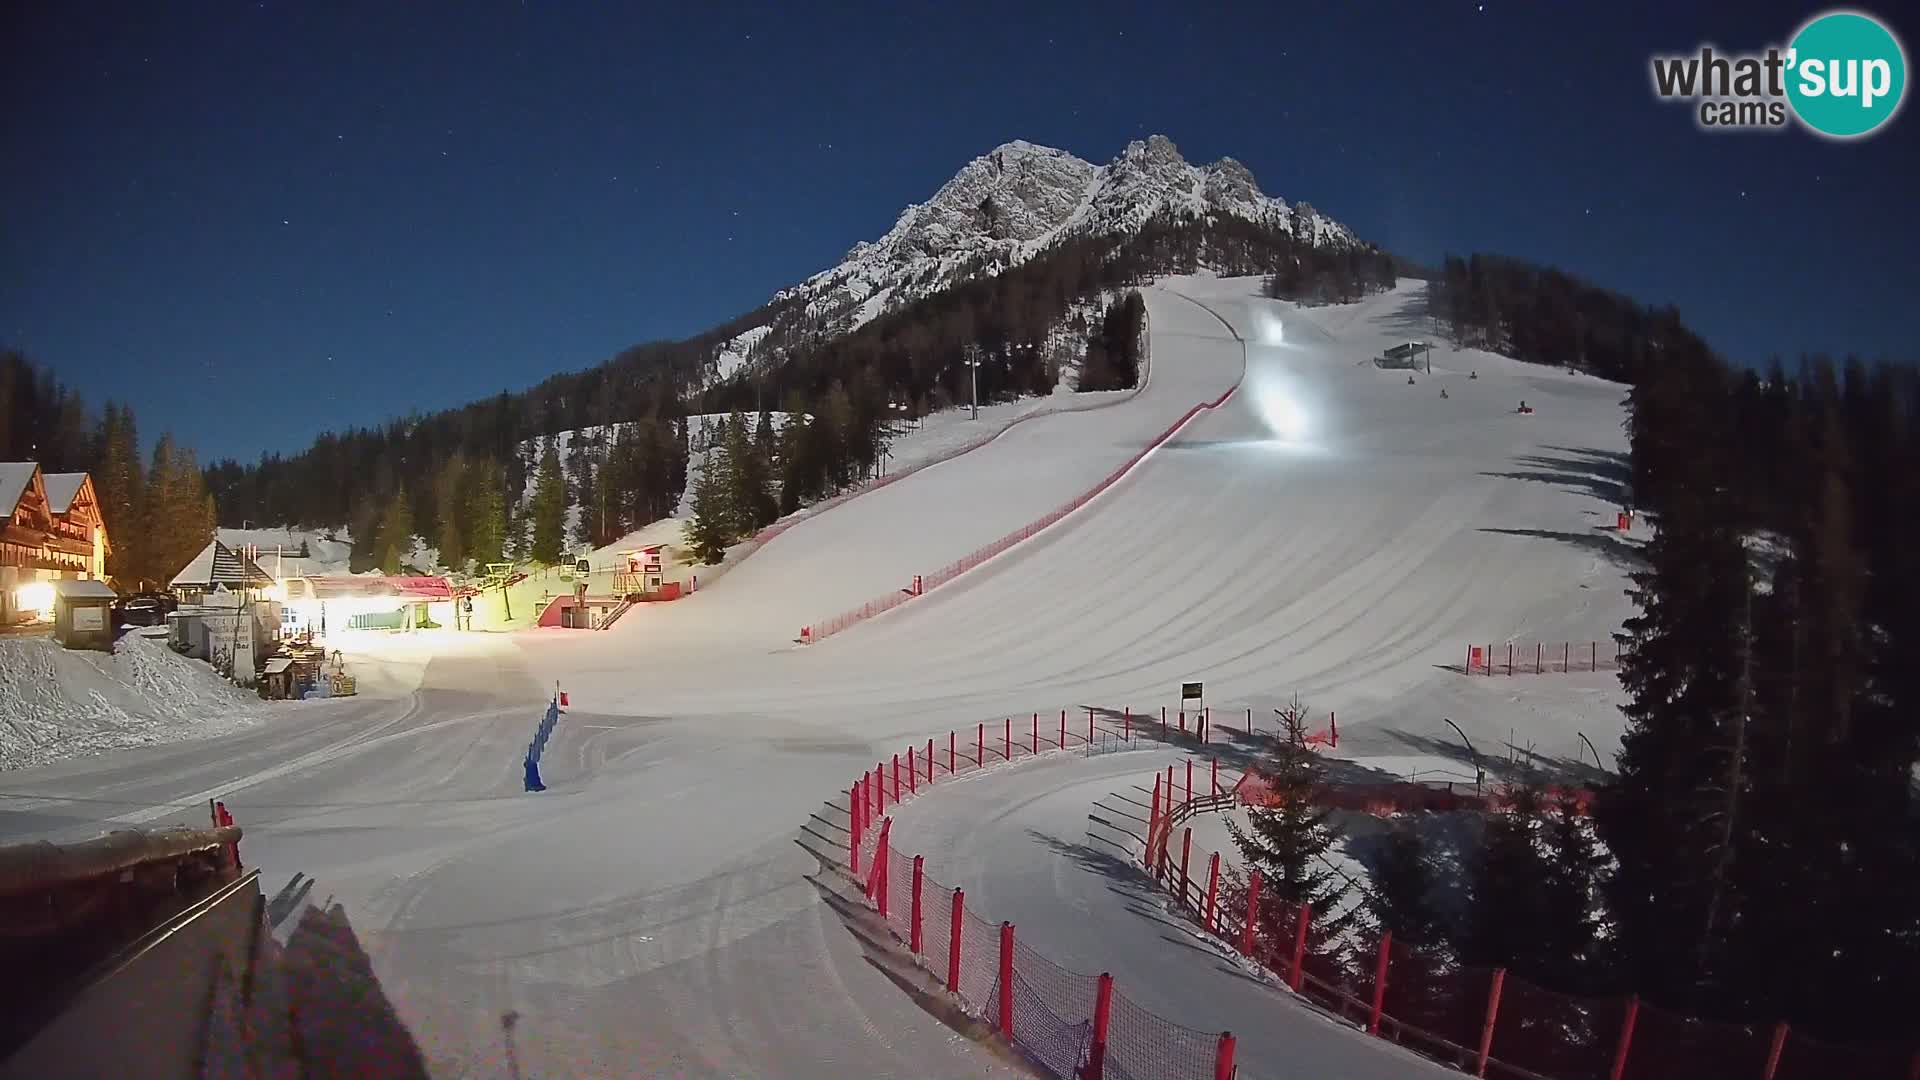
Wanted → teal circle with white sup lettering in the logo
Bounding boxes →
[1788,12,1907,138]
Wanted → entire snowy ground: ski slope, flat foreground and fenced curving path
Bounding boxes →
[0,277,1636,1080]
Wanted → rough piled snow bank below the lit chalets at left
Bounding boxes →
[0,634,267,769]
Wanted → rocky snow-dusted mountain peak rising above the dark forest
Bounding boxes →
[744,135,1356,345]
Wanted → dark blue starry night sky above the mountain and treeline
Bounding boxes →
[0,0,1920,459]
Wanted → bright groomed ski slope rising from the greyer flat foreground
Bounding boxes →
[522,277,1636,759]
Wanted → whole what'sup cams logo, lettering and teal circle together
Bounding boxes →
[1651,12,1907,138]
